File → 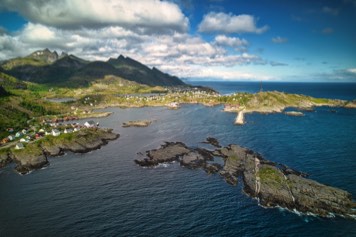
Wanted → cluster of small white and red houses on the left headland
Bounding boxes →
[0,120,99,150]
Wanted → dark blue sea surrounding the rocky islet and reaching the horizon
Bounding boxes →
[0,82,356,237]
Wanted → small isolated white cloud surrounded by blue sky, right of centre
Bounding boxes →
[198,12,269,34]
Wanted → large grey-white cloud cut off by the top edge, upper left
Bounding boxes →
[0,0,189,32]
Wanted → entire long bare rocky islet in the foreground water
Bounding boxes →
[135,139,356,219]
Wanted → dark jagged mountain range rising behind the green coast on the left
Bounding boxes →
[0,49,185,87]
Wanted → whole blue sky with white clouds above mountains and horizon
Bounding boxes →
[0,0,356,82]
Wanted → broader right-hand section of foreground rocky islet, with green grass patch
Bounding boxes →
[220,145,356,217]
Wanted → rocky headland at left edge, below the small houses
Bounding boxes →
[0,128,119,174]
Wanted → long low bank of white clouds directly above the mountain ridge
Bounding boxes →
[0,23,269,79]
